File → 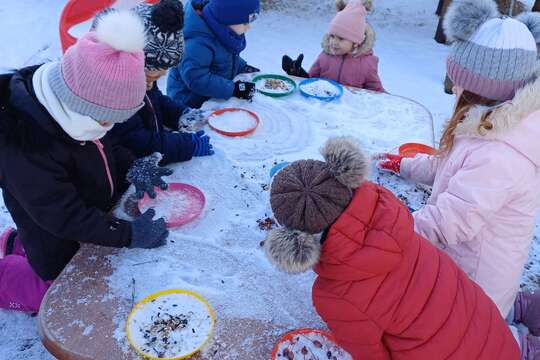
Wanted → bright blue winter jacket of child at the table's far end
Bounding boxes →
[167,3,246,108]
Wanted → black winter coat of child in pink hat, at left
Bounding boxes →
[0,67,134,280]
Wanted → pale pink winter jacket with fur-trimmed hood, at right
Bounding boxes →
[401,80,540,317]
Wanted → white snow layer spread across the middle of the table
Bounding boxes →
[104,86,432,359]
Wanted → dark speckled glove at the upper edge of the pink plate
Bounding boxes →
[127,153,173,199]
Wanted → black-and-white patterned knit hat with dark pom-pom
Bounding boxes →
[135,0,184,70]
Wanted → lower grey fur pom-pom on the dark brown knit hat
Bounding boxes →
[264,228,321,273]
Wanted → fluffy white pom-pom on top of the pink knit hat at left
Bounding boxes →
[96,10,145,53]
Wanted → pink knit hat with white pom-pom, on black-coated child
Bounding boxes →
[48,11,146,122]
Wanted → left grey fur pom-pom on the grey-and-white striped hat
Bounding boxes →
[443,0,499,41]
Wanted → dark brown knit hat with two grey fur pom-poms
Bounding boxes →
[264,137,369,273]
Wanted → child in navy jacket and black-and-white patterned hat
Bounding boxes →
[96,0,214,164]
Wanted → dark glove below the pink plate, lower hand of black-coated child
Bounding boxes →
[128,209,169,249]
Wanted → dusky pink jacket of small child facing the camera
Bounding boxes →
[309,25,384,92]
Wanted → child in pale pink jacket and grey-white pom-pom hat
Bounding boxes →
[379,0,540,358]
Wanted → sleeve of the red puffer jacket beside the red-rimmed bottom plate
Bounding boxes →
[315,292,390,360]
